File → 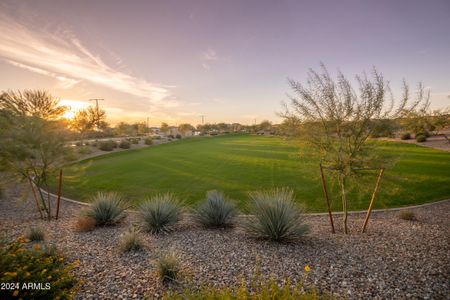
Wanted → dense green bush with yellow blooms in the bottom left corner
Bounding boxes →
[0,238,78,299]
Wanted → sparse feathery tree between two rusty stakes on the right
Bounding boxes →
[282,65,429,233]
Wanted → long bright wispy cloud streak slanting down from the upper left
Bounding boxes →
[0,12,171,107]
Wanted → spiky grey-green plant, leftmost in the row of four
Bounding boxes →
[86,192,125,226]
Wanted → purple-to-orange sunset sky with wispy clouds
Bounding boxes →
[0,0,450,126]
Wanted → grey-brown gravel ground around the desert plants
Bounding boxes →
[0,188,450,299]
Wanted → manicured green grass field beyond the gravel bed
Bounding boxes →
[59,135,450,212]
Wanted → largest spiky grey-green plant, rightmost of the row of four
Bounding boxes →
[244,188,308,242]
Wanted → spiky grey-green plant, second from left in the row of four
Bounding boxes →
[139,193,181,234]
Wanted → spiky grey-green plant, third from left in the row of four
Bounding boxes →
[196,191,236,227]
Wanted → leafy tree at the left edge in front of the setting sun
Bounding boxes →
[0,91,67,219]
